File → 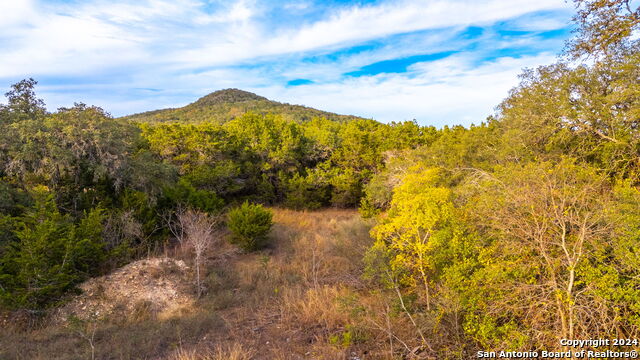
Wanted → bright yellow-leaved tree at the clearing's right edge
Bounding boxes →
[366,166,473,347]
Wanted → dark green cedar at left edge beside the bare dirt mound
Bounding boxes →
[0,187,105,309]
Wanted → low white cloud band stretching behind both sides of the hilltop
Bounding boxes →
[32,53,554,127]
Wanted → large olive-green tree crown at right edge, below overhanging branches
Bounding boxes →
[498,54,640,181]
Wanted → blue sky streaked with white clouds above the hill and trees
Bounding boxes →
[0,0,574,127]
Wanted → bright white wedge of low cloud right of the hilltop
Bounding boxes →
[252,54,554,126]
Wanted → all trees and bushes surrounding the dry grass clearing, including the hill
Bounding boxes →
[0,0,640,358]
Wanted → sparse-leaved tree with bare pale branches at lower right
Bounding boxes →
[466,159,617,348]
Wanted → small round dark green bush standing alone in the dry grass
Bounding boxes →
[228,202,273,251]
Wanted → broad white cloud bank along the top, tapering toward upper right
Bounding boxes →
[0,0,566,77]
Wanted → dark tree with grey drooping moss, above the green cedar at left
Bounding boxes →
[3,100,137,216]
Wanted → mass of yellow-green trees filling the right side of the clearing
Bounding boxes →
[361,1,640,357]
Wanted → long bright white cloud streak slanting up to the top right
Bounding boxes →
[170,0,568,66]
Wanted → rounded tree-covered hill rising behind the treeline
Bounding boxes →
[123,89,359,123]
